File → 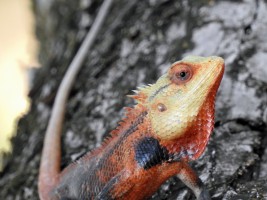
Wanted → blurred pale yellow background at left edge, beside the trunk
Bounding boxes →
[0,0,38,160]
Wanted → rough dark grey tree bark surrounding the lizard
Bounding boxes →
[0,0,267,200]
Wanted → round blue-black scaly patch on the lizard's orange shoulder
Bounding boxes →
[135,137,169,169]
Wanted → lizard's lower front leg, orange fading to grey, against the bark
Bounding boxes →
[177,162,211,200]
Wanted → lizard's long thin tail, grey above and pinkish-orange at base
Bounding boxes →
[38,0,113,200]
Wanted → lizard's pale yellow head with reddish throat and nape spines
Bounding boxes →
[131,56,224,140]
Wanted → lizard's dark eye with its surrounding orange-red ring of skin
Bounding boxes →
[171,65,192,84]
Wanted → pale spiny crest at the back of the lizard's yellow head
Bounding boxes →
[127,84,153,104]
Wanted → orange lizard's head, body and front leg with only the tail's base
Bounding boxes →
[38,56,224,200]
